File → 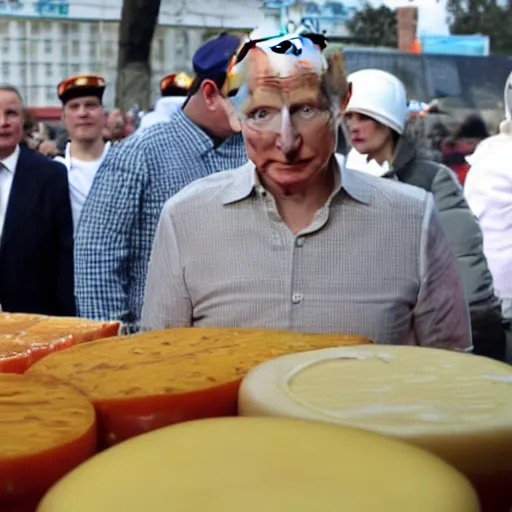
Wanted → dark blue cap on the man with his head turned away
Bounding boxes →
[192,33,240,77]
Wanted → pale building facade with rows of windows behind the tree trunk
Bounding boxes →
[0,0,263,108]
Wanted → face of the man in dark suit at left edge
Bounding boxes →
[0,89,23,158]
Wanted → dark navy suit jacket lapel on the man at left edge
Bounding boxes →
[0,147,40,249]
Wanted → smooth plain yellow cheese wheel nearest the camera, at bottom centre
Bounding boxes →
[37,418,479,512]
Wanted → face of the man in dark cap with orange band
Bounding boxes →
[64,96,105,142]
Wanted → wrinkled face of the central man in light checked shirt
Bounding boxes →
[240,50,336,187]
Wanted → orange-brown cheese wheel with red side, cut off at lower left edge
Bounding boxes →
[0,374,97,510]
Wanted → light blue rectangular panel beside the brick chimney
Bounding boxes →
[420,35,490,57]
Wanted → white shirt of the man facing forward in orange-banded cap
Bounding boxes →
[55,142,110,233]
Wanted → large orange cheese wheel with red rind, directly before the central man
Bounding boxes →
[29,328,368,446]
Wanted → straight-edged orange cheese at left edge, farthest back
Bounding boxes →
[0,313,119,373]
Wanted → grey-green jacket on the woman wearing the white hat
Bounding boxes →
[387,137,505,360]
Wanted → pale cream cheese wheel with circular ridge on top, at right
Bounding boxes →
[239,346,512,512]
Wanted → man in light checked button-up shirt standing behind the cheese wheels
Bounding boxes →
[142,25,472,351]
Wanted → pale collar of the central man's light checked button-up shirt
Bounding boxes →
[222,154,373,205]
